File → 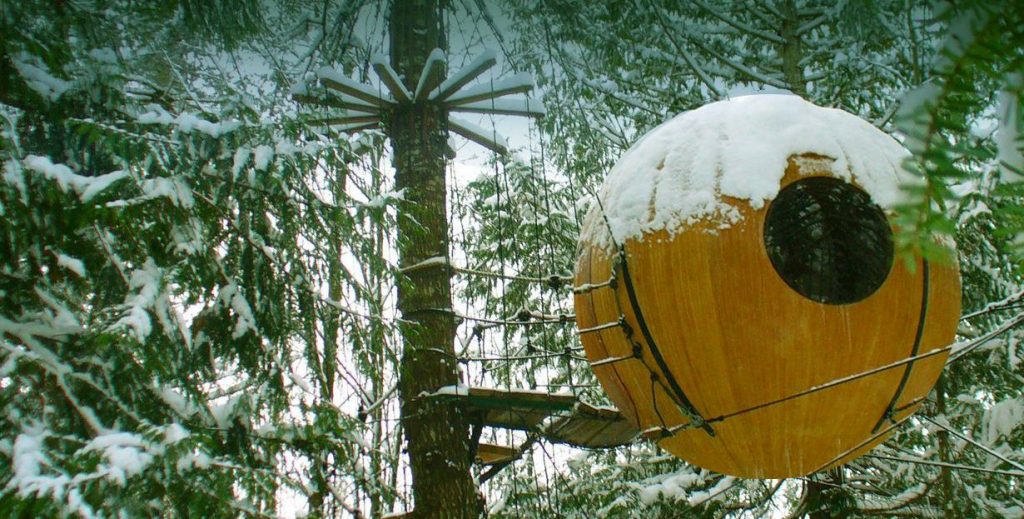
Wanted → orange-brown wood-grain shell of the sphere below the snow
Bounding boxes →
[577,156,959,478]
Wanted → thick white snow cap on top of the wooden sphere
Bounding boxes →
[590,94,910,244]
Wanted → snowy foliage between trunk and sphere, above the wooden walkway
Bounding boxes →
[454,154,601,399]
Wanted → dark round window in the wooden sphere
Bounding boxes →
[764,177,893,305]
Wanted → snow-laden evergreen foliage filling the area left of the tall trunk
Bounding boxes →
[0,2,403,517]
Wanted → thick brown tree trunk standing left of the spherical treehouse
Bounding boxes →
[388,0,482,518]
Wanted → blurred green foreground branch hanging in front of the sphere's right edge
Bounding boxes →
[896,2,1024,261]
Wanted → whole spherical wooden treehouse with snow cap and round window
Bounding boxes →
[574,95,959,478]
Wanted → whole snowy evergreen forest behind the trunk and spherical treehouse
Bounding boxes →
[0,0,1024,517]
